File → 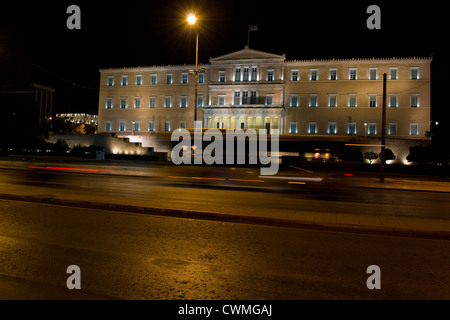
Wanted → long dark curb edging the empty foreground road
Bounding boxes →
[0,193,450,240]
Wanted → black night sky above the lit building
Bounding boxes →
[0,0,450,122]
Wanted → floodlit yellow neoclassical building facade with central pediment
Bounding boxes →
[98,47,431,138]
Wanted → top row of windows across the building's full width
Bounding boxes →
[107,67,419,86]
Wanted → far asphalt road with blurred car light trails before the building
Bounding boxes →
[0,167,450,219]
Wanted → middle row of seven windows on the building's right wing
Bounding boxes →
[289,94,419,108]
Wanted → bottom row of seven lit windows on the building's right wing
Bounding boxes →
[289,122,419,136]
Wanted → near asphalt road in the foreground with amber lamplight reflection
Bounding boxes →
[0,200,450,300]
